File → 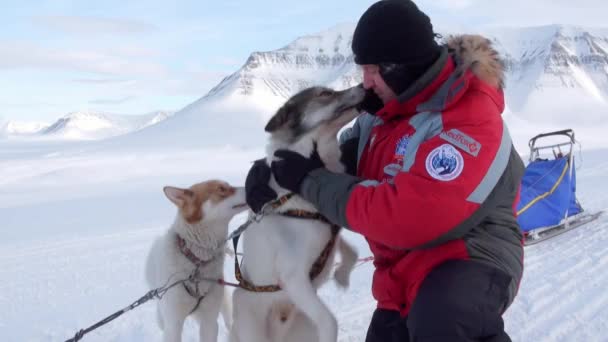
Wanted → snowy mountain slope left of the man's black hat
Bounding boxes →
[98,25,361,148]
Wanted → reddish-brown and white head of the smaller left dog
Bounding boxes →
[163,180,248,224]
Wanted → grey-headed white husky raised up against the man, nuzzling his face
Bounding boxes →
[231,83,365,342]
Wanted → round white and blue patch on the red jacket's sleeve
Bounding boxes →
[426,144,464,182]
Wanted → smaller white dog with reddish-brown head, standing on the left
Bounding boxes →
[146,181,247,342]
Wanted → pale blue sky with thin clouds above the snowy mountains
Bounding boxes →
[0,0,608,122]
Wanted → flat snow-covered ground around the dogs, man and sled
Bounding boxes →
[0,130,608,342]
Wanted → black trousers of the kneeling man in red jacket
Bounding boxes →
[365,260,511,342]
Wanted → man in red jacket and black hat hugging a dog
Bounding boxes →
[246,0,524,342]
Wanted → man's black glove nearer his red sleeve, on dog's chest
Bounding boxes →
[270,143,325,194]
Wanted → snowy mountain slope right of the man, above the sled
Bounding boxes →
[489,25,608,124]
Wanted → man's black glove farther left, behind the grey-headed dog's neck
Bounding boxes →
[245,158,277,213]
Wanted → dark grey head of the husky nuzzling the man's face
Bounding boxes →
[264,86,365,142]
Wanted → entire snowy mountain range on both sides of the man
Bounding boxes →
[114,24,608,152]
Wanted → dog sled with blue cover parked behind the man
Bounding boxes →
[517,129,601,245]
